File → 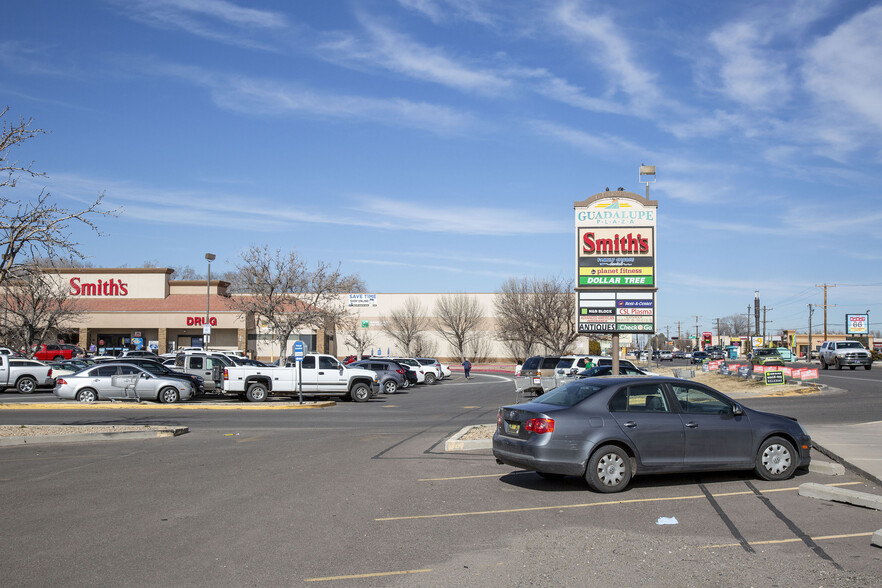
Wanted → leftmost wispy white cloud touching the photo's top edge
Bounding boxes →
[105,0,289,50]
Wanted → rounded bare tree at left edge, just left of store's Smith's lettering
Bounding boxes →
[0,266,81,356]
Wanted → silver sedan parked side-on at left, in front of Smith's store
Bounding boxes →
[53,363,193,404]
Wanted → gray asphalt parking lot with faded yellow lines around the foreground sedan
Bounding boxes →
[0,374,882,586]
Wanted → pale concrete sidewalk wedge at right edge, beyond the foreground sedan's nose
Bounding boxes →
[806,421,882,486]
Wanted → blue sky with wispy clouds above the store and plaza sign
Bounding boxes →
[0,0,882,332]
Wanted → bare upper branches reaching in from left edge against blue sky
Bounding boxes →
[0,107,119,284]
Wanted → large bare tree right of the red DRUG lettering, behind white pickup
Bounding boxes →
[229,245,359,357]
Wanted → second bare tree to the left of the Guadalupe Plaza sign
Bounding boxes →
[493,278,539,363]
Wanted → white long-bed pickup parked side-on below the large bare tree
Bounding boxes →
[223,354,380,402]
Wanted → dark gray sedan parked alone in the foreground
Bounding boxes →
[493,377,811,493]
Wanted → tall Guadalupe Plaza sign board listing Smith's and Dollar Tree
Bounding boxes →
[573,191,658,333]
